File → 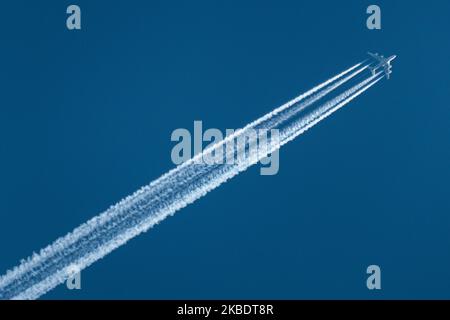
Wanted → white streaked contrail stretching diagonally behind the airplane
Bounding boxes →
[0,61,384,299]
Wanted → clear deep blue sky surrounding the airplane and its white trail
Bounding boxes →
[0,1,450,299]
